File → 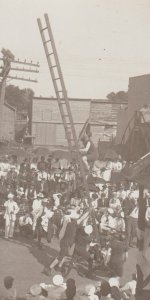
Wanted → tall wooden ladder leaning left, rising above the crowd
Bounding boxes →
[37,14,99,239]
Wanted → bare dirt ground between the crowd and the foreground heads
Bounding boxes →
[0,235,136,298]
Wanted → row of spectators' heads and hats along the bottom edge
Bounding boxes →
[0,274,136,300]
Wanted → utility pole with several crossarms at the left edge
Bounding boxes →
[0,48,39,141]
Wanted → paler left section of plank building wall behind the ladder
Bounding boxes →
[31,98,90,147]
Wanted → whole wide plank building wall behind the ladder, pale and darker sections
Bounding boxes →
[31,97,126,147]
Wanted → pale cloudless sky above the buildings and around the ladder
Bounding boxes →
[0,0,150,99]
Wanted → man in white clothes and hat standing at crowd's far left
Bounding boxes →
[4,193,19,239]
